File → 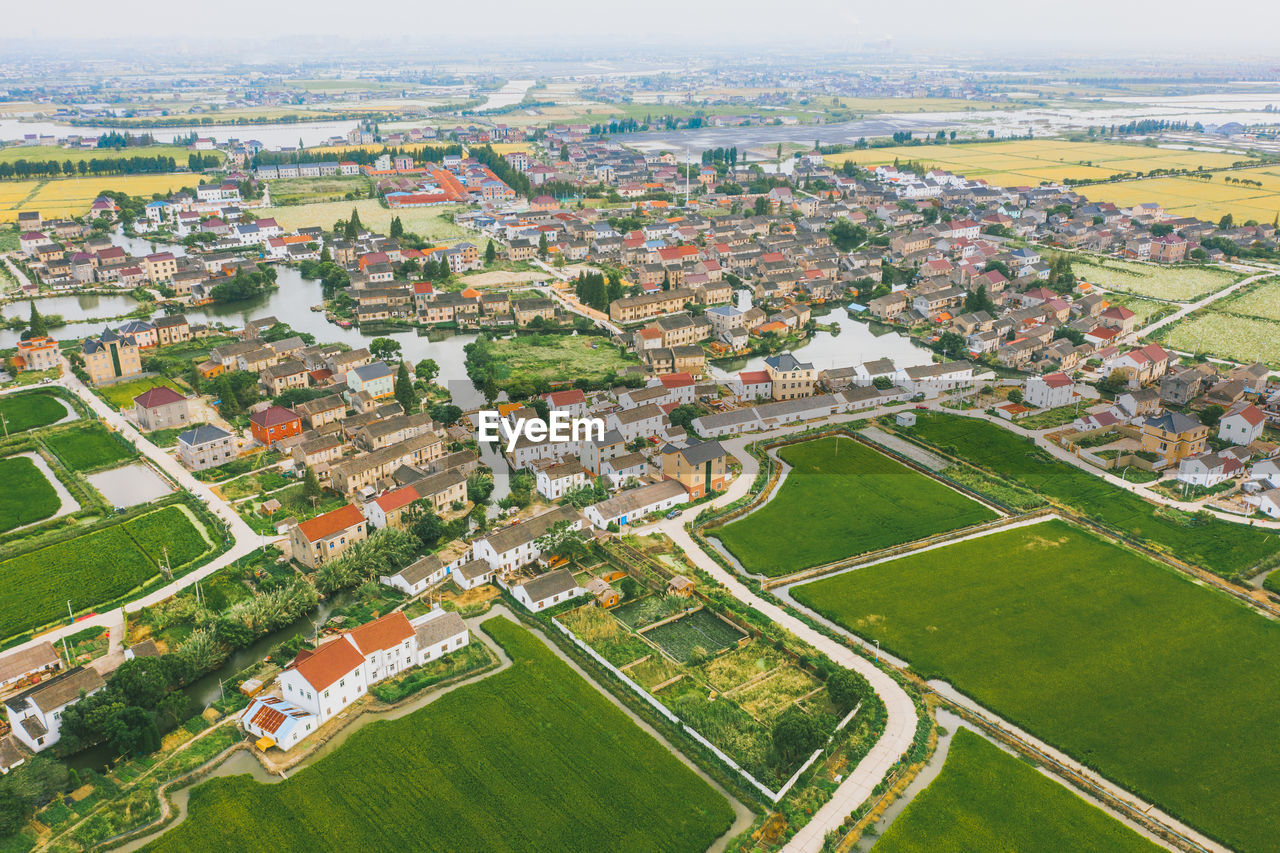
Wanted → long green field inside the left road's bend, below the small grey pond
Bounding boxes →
[0,507,205,638]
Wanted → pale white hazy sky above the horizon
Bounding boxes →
[0,0,1280,54]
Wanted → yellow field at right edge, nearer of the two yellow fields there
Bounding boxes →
[1080,164,1280,223]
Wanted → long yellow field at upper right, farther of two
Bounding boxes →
[826,140,1240,185]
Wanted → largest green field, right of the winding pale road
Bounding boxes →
[794,521,1280,850]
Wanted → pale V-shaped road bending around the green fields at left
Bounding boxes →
[9,361,275,651]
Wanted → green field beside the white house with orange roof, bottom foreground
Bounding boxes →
[137,617,733,853]
